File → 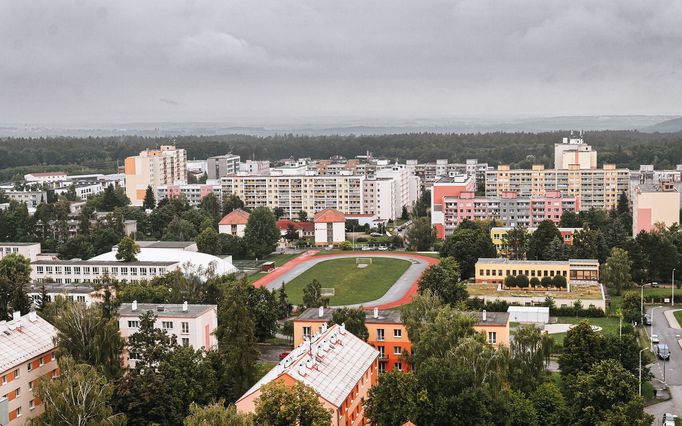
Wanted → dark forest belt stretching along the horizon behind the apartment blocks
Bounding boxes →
[0,131,682,181]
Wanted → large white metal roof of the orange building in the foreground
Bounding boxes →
[240,324,379,407]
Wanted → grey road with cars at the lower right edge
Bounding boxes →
[646,306,682,421]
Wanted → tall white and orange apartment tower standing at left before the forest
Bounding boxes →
[125,145,187,206]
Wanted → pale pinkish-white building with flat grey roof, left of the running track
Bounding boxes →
[118,301,218,367]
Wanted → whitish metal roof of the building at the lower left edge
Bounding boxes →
[0,314,57,373]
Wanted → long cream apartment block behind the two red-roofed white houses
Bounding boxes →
[221,175,365,219]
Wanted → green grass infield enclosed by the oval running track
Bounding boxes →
[286,256,410,306]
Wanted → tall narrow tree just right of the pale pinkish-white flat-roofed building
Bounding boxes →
[216,280,259,401]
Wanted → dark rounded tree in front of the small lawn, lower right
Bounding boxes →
[559,321,604,377]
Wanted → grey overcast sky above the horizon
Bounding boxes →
[0,0,682,123]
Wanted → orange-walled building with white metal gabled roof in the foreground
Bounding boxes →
[235,323,379,426]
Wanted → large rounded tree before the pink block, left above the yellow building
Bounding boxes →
[440,220,497,279]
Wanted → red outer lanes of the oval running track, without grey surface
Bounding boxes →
[253,250,440,309]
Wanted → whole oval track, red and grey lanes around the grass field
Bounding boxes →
[253,251,440,309]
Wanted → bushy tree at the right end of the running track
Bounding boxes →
[418,257,469,305]
